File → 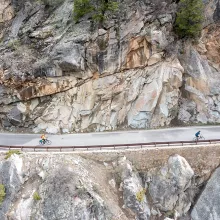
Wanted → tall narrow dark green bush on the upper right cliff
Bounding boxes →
[175,0,204,38]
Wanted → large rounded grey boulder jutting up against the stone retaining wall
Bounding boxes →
[149,155,194,215]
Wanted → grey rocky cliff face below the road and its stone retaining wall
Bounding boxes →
[0,153,220,220]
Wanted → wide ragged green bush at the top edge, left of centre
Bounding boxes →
[73,0,118,23]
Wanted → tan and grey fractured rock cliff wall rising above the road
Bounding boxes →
[0,0,220,133]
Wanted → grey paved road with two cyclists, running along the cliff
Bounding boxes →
[0,126,220,146]
